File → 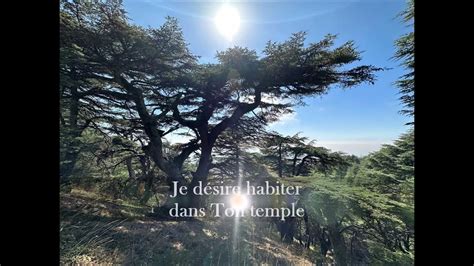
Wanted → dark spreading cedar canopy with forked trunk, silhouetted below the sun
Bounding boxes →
[60,1,380,203]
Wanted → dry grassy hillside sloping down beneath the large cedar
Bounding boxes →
[60,190,317,265]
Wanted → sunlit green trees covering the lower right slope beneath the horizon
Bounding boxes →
[291,131,414,265]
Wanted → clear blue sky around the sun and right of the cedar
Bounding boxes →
[124,0,410,155]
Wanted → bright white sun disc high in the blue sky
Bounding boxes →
[214,4,240,41]
